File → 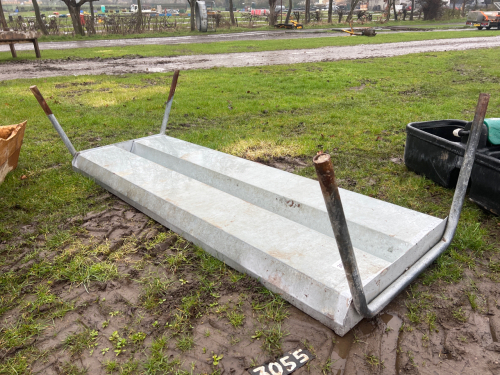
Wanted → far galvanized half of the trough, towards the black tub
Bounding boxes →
[132,135,445,262]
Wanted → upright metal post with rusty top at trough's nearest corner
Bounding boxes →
[313,154,367,315]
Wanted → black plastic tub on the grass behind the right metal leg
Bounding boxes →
[404,120,500,215]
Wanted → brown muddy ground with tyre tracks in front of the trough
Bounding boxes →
[0,158,500,375]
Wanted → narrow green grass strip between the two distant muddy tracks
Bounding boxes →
[0,29,498,63]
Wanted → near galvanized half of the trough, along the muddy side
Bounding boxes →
[73,146,390,335]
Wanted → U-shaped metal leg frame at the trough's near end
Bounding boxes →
[313,94,490,318]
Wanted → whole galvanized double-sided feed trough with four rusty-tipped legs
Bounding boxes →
[32,78,488,335]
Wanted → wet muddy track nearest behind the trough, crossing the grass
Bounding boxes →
[0,36,500,80]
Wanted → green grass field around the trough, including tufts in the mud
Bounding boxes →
[0,47,500,374]
